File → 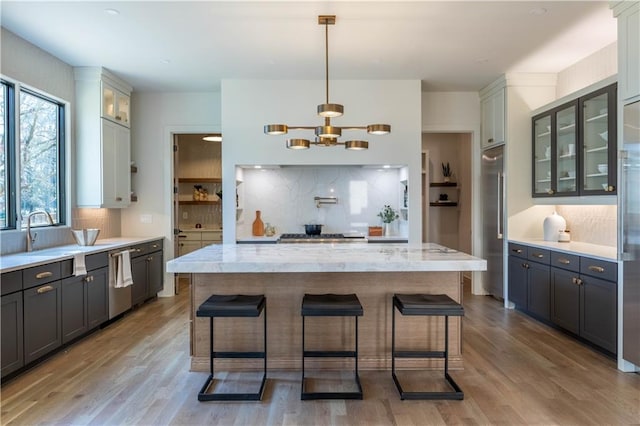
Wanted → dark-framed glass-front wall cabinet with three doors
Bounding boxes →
[532,84,616,197]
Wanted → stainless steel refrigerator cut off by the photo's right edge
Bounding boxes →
[618,101,640,368]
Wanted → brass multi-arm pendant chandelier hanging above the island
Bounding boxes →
[264,15,391,151]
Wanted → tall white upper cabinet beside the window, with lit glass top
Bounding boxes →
[74,67,131,208]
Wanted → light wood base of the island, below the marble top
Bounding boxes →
[191,271,462,371]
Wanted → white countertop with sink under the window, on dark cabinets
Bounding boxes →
[0,236,163,272]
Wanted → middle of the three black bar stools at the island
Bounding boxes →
[300,294,363,400]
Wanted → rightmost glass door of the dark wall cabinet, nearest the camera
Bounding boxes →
[581,84,616,193]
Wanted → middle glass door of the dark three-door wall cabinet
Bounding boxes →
[554,103,578,195]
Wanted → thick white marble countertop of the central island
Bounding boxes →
[167,243,487,273]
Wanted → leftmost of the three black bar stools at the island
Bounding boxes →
[196,294,267,401]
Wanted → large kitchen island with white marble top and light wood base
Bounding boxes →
[167,244,486,371]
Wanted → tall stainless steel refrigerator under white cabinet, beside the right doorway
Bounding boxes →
[481,146,505,299]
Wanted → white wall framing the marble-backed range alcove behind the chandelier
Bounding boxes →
[222,80,421,243]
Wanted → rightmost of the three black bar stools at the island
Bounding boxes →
[391,294,464,400]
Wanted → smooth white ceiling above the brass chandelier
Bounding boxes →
[0,0,616,92]
